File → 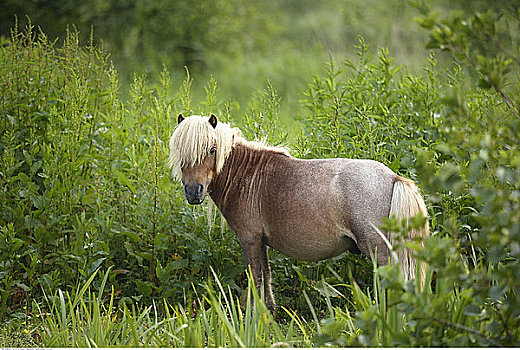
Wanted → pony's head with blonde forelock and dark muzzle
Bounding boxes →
[168,114,240,204]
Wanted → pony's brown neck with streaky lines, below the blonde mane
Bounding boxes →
[209,143,286,219]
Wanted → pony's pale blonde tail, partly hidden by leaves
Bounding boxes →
[389,176,430,288]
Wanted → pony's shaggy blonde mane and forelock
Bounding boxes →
[168,115,289,180]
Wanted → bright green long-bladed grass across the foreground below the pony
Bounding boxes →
[24,249,482,347]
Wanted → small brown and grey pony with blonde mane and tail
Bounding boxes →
[168,114,429,310]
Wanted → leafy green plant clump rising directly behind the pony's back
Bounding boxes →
[296,39,442,171]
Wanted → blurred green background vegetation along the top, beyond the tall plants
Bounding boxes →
[0,0,434,124]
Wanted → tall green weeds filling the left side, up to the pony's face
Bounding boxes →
[0,20,245,317]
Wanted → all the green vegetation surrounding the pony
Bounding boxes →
[0,0,520,347]
